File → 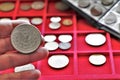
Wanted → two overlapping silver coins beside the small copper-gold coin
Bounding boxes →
[49,17,61,30]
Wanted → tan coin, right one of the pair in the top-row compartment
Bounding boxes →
[31,1,45,10]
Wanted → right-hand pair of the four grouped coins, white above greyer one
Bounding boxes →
[58,35,72,50]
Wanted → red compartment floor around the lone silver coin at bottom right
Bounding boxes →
[78,52,112,75]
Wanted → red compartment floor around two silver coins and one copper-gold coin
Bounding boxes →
[45,16,74,32]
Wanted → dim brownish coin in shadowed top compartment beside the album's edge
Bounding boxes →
[55,1,69,11]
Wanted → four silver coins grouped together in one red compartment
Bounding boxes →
[44,34,72,51]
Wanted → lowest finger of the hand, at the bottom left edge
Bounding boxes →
[0,70,41,80]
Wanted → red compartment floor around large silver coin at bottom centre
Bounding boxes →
[38,53,74,76]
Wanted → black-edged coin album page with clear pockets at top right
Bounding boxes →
[64,0,120,39]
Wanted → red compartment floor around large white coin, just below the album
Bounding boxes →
[77,32,108,52]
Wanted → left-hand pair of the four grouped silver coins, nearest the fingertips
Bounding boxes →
[44,35,58,51]
